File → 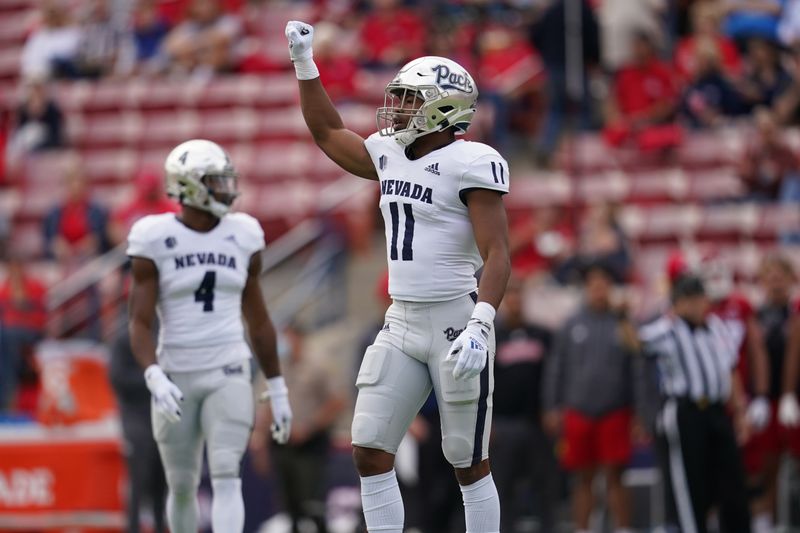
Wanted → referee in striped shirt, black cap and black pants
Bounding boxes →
[639,275,750,533]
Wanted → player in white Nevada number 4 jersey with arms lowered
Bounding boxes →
[128,139,292,533]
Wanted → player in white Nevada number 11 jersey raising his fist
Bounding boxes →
[286,21,510,533]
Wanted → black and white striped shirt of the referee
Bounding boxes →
[639,315,738,402]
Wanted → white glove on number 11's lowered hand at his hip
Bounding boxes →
[446,302,495,380]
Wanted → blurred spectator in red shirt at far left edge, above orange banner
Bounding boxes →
[0,256,47,411]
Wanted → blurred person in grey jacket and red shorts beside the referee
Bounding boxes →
[543,264,635,532]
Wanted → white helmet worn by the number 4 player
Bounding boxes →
[164,139,239,218]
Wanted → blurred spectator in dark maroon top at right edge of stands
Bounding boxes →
[739,108,800,202]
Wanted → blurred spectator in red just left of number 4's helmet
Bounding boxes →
[109,170,178,244]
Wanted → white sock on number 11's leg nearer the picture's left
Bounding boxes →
[361,468,405,533]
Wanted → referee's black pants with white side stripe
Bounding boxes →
[659,398,750,533]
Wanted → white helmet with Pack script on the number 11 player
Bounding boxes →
[377,56,478,146]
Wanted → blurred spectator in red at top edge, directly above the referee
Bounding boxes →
[675,2,742,80]
